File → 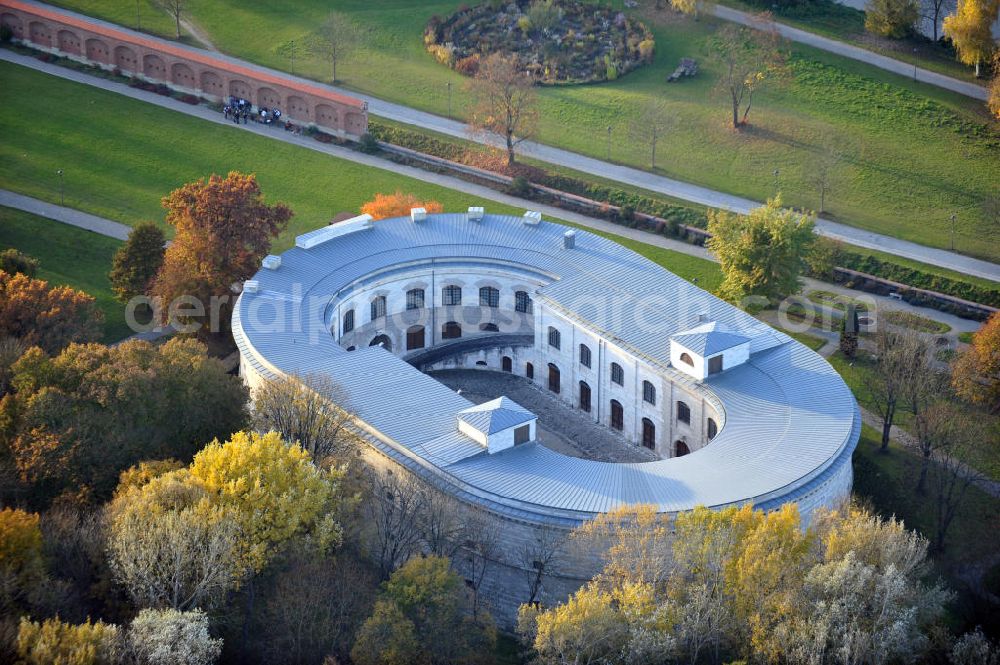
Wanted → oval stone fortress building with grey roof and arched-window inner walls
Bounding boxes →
[233,208,861,624]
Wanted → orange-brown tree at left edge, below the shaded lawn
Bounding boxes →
[0,270,104,353]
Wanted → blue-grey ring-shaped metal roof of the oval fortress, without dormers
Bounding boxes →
[233,214,860,518]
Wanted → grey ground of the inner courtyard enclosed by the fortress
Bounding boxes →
[428,369,659,462]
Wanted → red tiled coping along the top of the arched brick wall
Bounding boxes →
[0,0,365,110]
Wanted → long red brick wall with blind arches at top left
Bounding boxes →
[0,0,368,137]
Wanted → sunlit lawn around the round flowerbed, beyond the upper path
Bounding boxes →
[50,0,1000,259]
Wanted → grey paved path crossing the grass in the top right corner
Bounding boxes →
[712,5,988,101]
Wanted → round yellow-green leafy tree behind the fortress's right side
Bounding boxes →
[708,197,816,302]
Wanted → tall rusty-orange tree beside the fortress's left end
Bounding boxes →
[152,171,292,334]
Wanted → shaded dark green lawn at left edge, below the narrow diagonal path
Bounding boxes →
[0,207,131,343]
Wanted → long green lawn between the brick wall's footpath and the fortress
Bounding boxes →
[0,63,721,289]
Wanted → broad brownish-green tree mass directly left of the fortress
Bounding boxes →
[0,339,248,498]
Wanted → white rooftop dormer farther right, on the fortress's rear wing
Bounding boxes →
[670,321,750,381]
